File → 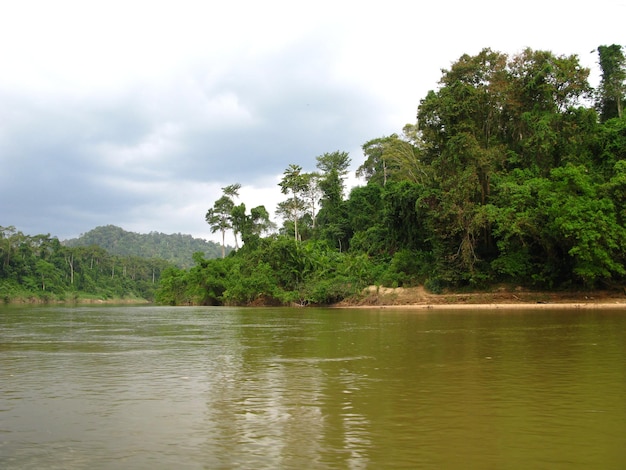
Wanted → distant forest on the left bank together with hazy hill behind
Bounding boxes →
[0,225,221,302]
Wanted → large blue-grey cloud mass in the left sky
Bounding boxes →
[0,37,382,236]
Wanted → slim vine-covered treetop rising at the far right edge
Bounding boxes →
[596,44,626,122]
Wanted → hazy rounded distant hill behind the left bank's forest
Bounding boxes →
[62,225,232,268]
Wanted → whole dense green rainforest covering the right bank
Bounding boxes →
[156,45,626,305]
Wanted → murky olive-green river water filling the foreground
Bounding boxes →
[0,307,626,469]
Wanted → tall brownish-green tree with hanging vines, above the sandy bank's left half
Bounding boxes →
[418,49,508,280]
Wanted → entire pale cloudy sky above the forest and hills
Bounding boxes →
[0,0,626,242]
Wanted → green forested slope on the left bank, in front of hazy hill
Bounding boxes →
[0,226,172,302]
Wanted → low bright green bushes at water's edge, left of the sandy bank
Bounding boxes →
[156,236,375,305]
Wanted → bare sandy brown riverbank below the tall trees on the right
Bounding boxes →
[334,286,626,309]
